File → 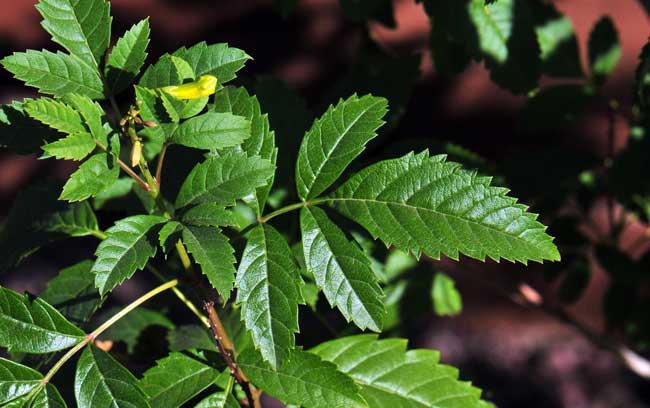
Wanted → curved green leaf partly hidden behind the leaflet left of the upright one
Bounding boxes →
[212,86,277,215]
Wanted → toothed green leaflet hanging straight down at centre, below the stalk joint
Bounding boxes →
[235,224,302,368]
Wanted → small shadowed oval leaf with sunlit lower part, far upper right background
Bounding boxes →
[589,16,622,85]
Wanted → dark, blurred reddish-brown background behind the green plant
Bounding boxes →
[0,0,650,408]
